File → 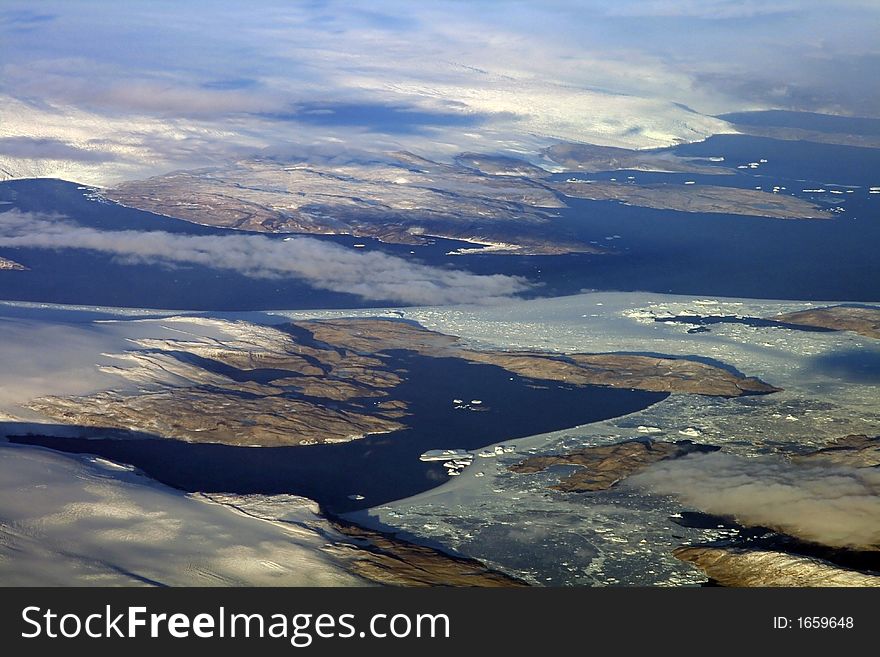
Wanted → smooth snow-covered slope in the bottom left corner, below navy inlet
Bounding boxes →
[0,444,365,586]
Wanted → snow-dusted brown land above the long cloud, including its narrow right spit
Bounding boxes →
[102,147,830,255]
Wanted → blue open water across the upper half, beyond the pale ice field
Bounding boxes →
[0,135,880,311]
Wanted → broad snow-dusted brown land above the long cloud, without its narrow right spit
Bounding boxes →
[106,153,599,255]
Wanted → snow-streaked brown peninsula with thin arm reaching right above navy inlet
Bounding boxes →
[27,317,778,446]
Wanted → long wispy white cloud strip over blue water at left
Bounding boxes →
[0,210,530,305]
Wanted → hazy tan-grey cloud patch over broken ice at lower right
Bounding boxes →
[627,452,880,550]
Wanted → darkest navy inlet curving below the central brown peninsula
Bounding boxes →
[7,351,667,513]
